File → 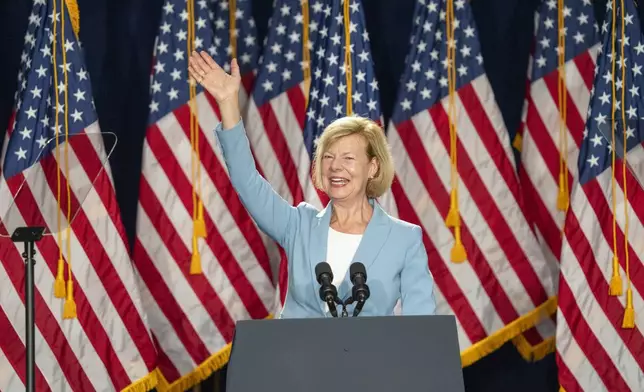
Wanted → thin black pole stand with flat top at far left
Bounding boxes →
[11,227,45,392]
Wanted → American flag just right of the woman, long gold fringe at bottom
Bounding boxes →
[380,0,556,365]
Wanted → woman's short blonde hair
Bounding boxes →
[313,116,394,198]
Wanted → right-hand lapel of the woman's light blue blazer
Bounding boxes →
[338,199,391,300]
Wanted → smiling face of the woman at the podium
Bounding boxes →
[321,134,378,201]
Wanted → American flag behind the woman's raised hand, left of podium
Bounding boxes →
[134,0,275,391]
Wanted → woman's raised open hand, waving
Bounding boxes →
[188,51,241,105]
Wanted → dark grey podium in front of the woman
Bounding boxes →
[226,316,465,392]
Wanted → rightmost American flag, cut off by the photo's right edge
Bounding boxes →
[556,0,644,392]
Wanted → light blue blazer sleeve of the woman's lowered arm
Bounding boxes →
[400,226,436,315]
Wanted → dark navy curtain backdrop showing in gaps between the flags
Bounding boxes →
[0,0,642,392]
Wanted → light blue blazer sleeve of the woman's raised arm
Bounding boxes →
[215,120,298,247]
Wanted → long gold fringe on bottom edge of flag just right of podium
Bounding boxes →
[461,296,557,367]
